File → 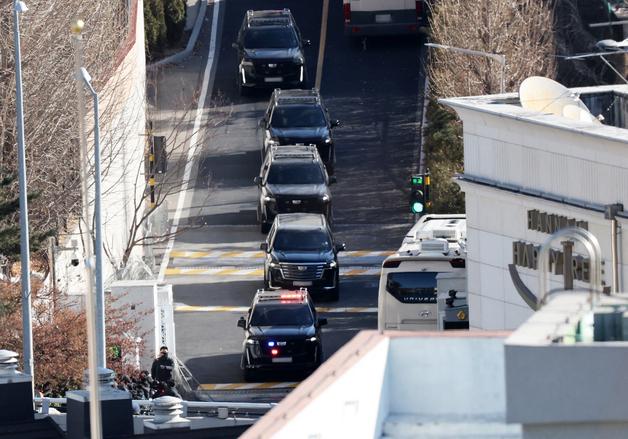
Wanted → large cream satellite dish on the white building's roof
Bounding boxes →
[519,76,600,124]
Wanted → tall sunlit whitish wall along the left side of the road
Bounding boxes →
[55,0,146,295]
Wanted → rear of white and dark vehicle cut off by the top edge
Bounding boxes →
[343,0,427,36]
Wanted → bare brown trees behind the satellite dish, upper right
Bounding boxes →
[428,0,556,97]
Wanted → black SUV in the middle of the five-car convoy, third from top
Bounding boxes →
[253,145,336,233]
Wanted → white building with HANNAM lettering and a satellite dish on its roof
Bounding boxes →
[441,85,628,330]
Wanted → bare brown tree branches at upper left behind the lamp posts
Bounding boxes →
[0,0,127,262]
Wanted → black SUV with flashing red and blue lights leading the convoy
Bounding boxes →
[238,288,327,381]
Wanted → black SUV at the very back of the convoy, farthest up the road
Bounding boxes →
[232,9,310,94]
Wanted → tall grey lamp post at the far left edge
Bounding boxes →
[13,0,35,383]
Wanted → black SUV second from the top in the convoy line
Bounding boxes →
[260,89,340,175]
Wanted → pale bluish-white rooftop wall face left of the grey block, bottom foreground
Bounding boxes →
[386,336,506,423]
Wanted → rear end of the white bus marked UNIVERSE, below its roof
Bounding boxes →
[377,255,466,331]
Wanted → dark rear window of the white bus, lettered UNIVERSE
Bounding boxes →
[386,272,438,303]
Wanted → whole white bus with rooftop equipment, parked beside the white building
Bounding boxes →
[377,214,467,331]
